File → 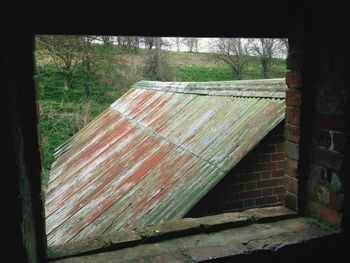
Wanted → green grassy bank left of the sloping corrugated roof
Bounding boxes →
[35,65,128,187]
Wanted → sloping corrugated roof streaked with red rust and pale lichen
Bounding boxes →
[45,79,285,248]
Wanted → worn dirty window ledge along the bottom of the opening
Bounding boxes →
[48,207,340,263]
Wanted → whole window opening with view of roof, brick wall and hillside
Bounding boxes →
[35,35,285,249]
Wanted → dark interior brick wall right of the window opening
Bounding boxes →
[285,6,350,227]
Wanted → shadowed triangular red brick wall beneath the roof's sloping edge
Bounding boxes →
[187,123,286,217]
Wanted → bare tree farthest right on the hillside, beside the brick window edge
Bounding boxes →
[249,38,279,79]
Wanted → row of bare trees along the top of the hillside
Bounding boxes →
[36,35,288,95]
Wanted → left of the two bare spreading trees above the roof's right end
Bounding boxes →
[214,38,249,79]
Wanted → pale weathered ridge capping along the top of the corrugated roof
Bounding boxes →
[133,78,287,98]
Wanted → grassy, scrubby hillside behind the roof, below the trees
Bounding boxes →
[35,46,285,187]
